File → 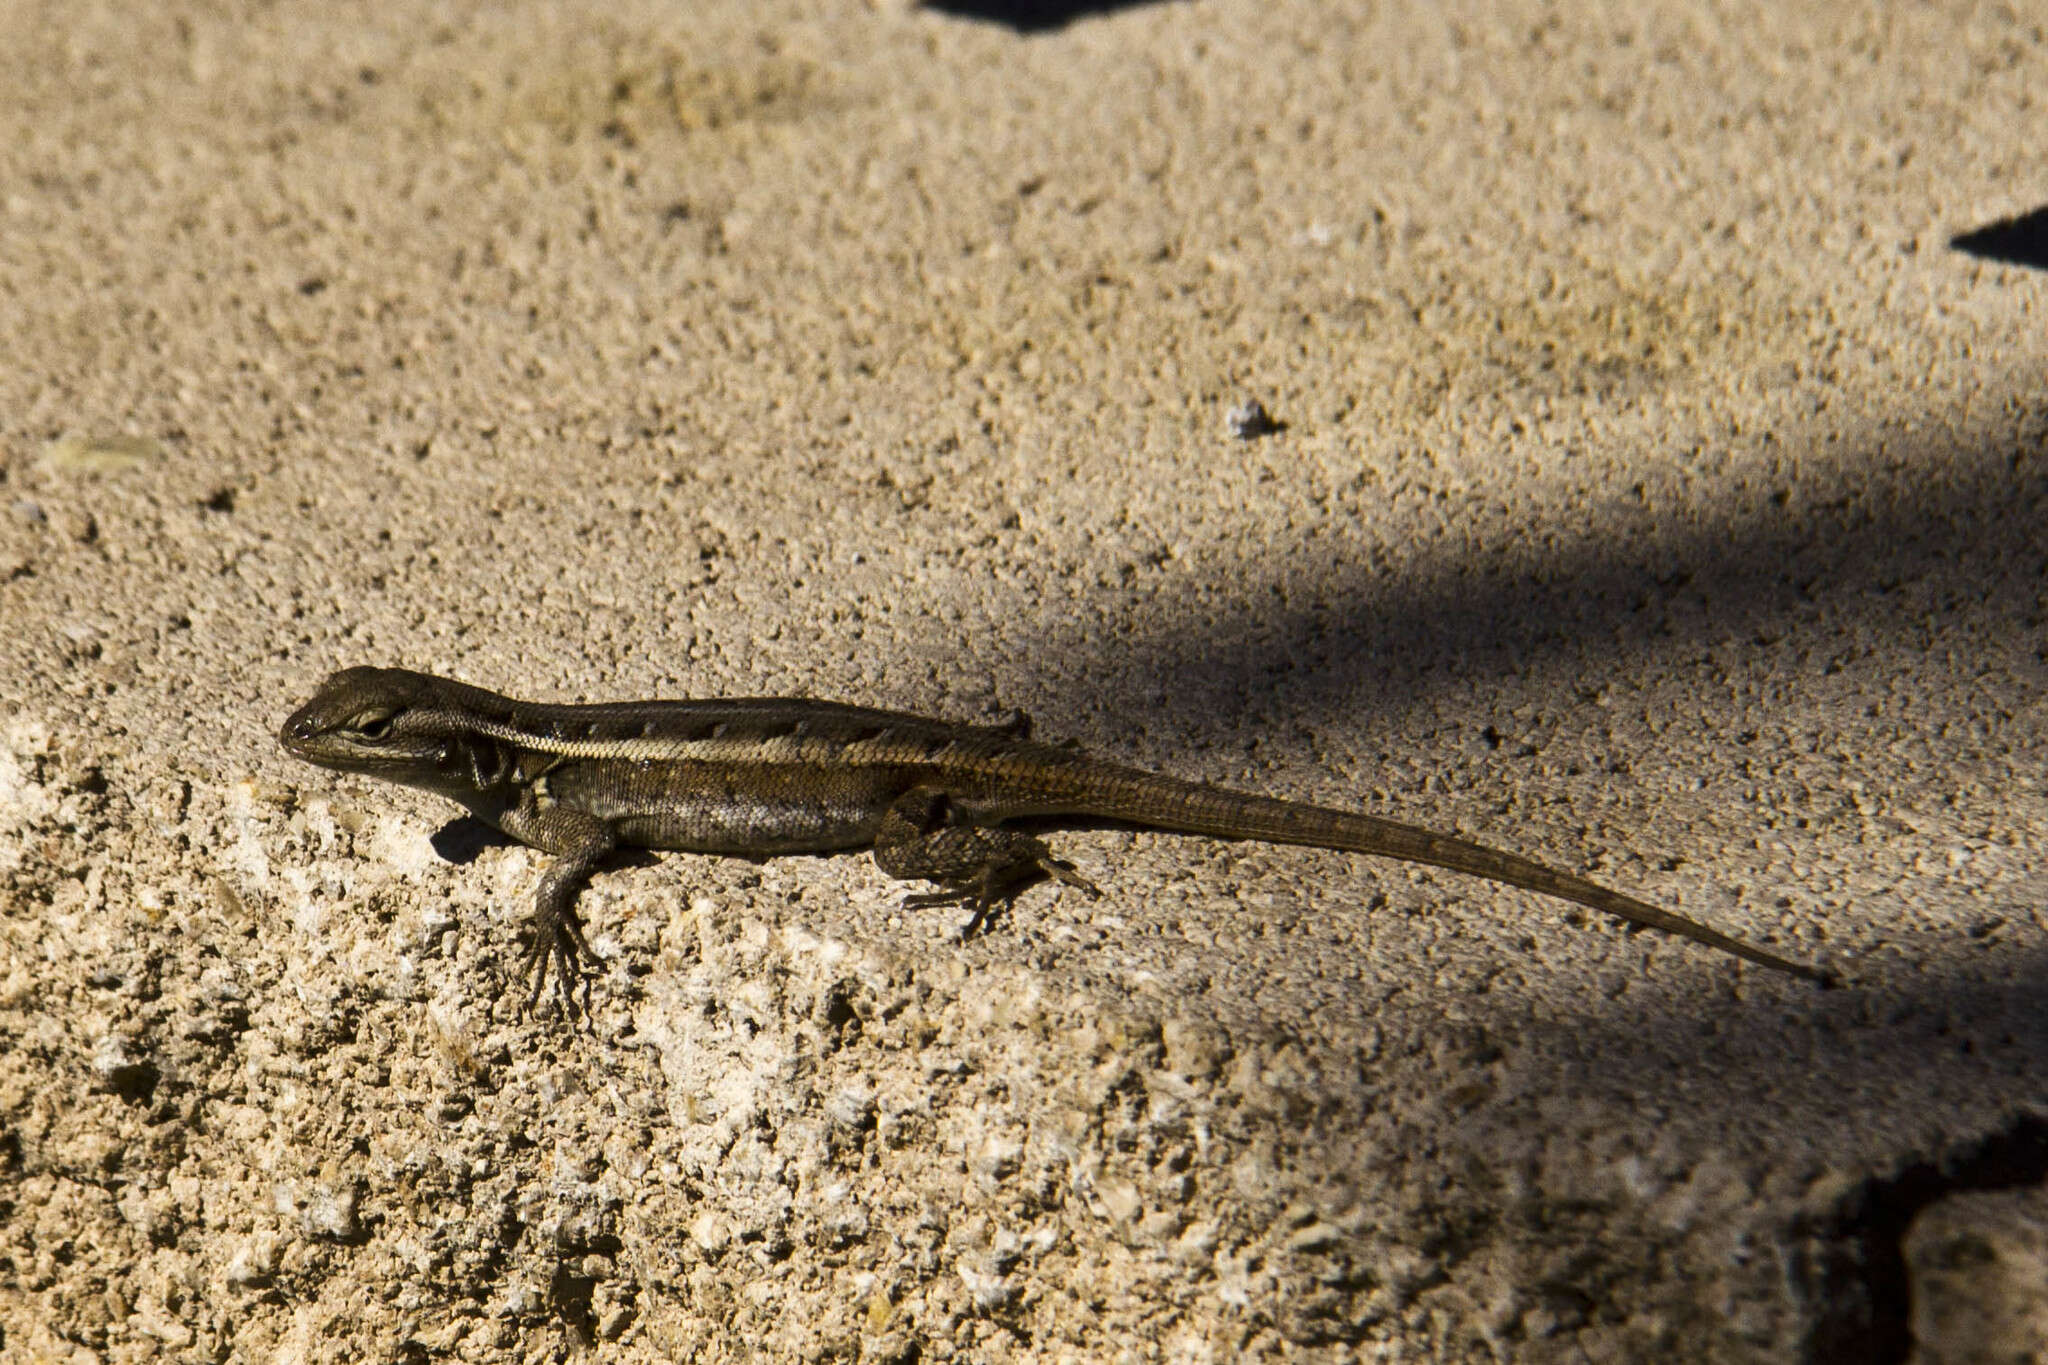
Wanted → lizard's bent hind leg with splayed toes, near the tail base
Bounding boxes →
[874,788,1102,937]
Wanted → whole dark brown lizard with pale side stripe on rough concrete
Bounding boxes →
[279,667,1835,1013]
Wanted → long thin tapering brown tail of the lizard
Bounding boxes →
[1069,769,1837,986]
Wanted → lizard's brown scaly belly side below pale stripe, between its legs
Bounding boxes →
[535,761,903,857]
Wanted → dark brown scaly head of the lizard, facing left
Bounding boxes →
[276,667,468,782]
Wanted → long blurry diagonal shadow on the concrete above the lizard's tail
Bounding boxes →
[1006,417,2048,757]
